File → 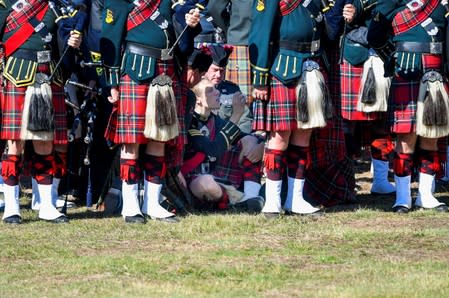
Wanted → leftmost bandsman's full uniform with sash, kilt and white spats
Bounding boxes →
[0,0,83,223]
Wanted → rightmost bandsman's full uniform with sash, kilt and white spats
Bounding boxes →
[368,0,449,213]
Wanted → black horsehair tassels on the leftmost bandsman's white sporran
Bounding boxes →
[27,87,55,131]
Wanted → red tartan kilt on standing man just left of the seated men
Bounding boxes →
[105,60,184,144]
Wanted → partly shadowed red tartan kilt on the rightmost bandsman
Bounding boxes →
[388,54,447,133]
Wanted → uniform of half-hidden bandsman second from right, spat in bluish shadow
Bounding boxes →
[340,0,395,194]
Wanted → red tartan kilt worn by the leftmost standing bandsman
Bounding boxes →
[0,64,67,145]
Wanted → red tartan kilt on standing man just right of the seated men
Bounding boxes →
[253,76,298,131]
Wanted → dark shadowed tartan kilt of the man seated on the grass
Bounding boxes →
[211,144,243,188]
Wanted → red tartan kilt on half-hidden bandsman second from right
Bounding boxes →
[340,60,379,120]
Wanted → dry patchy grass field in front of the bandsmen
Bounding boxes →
[0,162,449,297]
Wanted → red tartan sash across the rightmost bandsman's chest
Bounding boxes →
[393,0,439,35]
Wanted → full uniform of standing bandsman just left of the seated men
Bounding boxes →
[100,0,200,223]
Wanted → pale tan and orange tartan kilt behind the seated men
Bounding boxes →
[226,45,252,102]
